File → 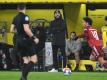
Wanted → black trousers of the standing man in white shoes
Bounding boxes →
[52,45,67,69]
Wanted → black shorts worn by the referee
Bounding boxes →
[17,36,36,57]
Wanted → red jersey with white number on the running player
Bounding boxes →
[84,27,102,46]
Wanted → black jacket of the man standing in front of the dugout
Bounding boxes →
[51,19,66,45]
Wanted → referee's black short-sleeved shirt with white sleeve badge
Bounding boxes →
[12,12,29,36]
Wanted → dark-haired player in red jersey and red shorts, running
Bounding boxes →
[83,17,107,68]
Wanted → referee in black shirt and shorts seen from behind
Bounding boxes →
[10,3,39,80]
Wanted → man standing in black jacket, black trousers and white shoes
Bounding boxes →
[49,10,66,72]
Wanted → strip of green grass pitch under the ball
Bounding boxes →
[0,72,107,80]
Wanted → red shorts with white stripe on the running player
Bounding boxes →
[91,46,103,59]
